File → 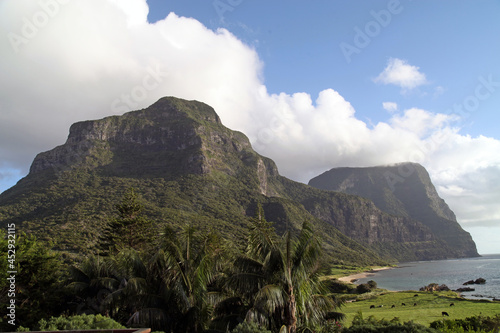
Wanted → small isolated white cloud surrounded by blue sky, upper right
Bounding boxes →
[373,58,427,91]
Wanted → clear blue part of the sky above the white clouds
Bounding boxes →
[148,0,500,138]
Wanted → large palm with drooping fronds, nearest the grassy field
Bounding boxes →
[228,210,338,333]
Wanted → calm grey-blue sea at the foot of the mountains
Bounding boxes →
[356,254,500,300]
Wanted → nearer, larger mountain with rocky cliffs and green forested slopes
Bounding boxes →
[0,97,476,265]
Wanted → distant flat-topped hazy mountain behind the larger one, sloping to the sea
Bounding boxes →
[309,163,478,257]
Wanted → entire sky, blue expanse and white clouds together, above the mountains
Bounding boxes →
[0,0,500,253]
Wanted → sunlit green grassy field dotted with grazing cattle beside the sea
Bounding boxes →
[340,291,500,326]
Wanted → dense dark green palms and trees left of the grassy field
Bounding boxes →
[1,190,341,332]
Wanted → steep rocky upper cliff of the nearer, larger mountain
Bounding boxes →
[30,98,275,178]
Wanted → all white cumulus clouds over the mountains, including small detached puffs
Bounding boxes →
[0,0,500,249]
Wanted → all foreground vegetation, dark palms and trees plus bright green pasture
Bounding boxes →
[0,195,499,332]
